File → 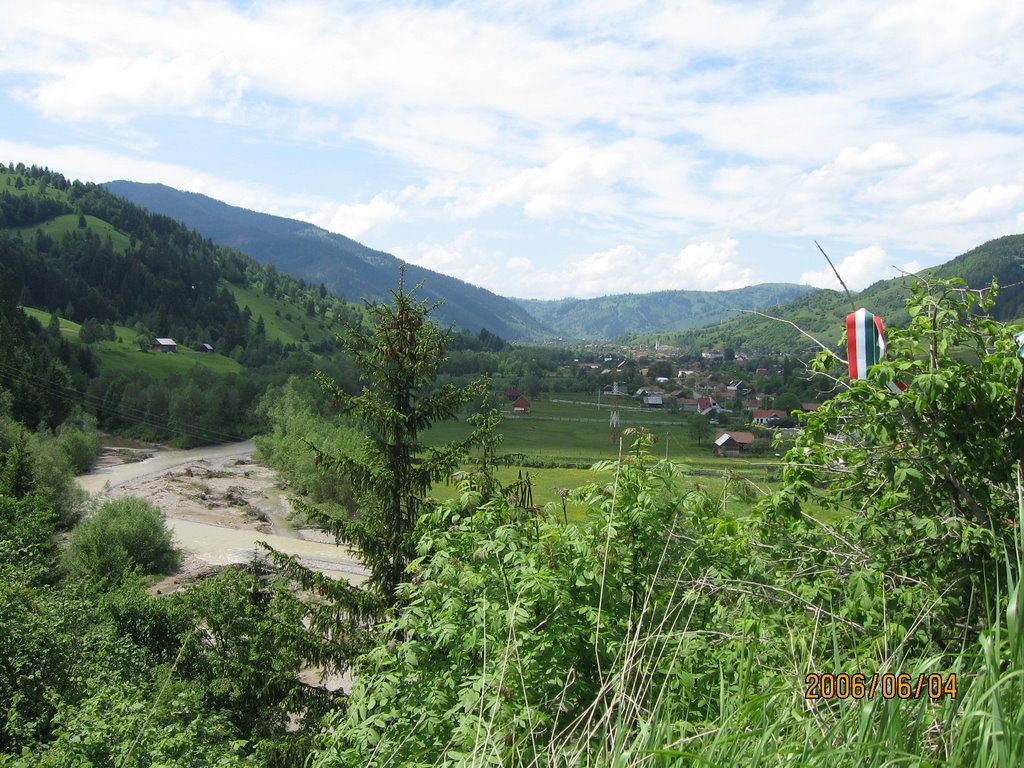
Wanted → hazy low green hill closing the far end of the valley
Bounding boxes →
[516,283,814,339]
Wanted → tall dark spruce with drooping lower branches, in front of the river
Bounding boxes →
[264,269,495,670]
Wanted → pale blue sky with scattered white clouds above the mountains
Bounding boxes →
[0,0,1024,299]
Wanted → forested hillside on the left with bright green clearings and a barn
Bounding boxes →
[0,164,360,444]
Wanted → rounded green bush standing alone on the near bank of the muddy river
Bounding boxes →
[67,498,178,583]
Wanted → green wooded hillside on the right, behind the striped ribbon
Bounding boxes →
[674,234,1024,352]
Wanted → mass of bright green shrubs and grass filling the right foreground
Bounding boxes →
[312,283,1024,768]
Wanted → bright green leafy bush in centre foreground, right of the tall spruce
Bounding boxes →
[314,435,731,767]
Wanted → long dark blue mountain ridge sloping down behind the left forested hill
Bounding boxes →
[103,181,543,339]
